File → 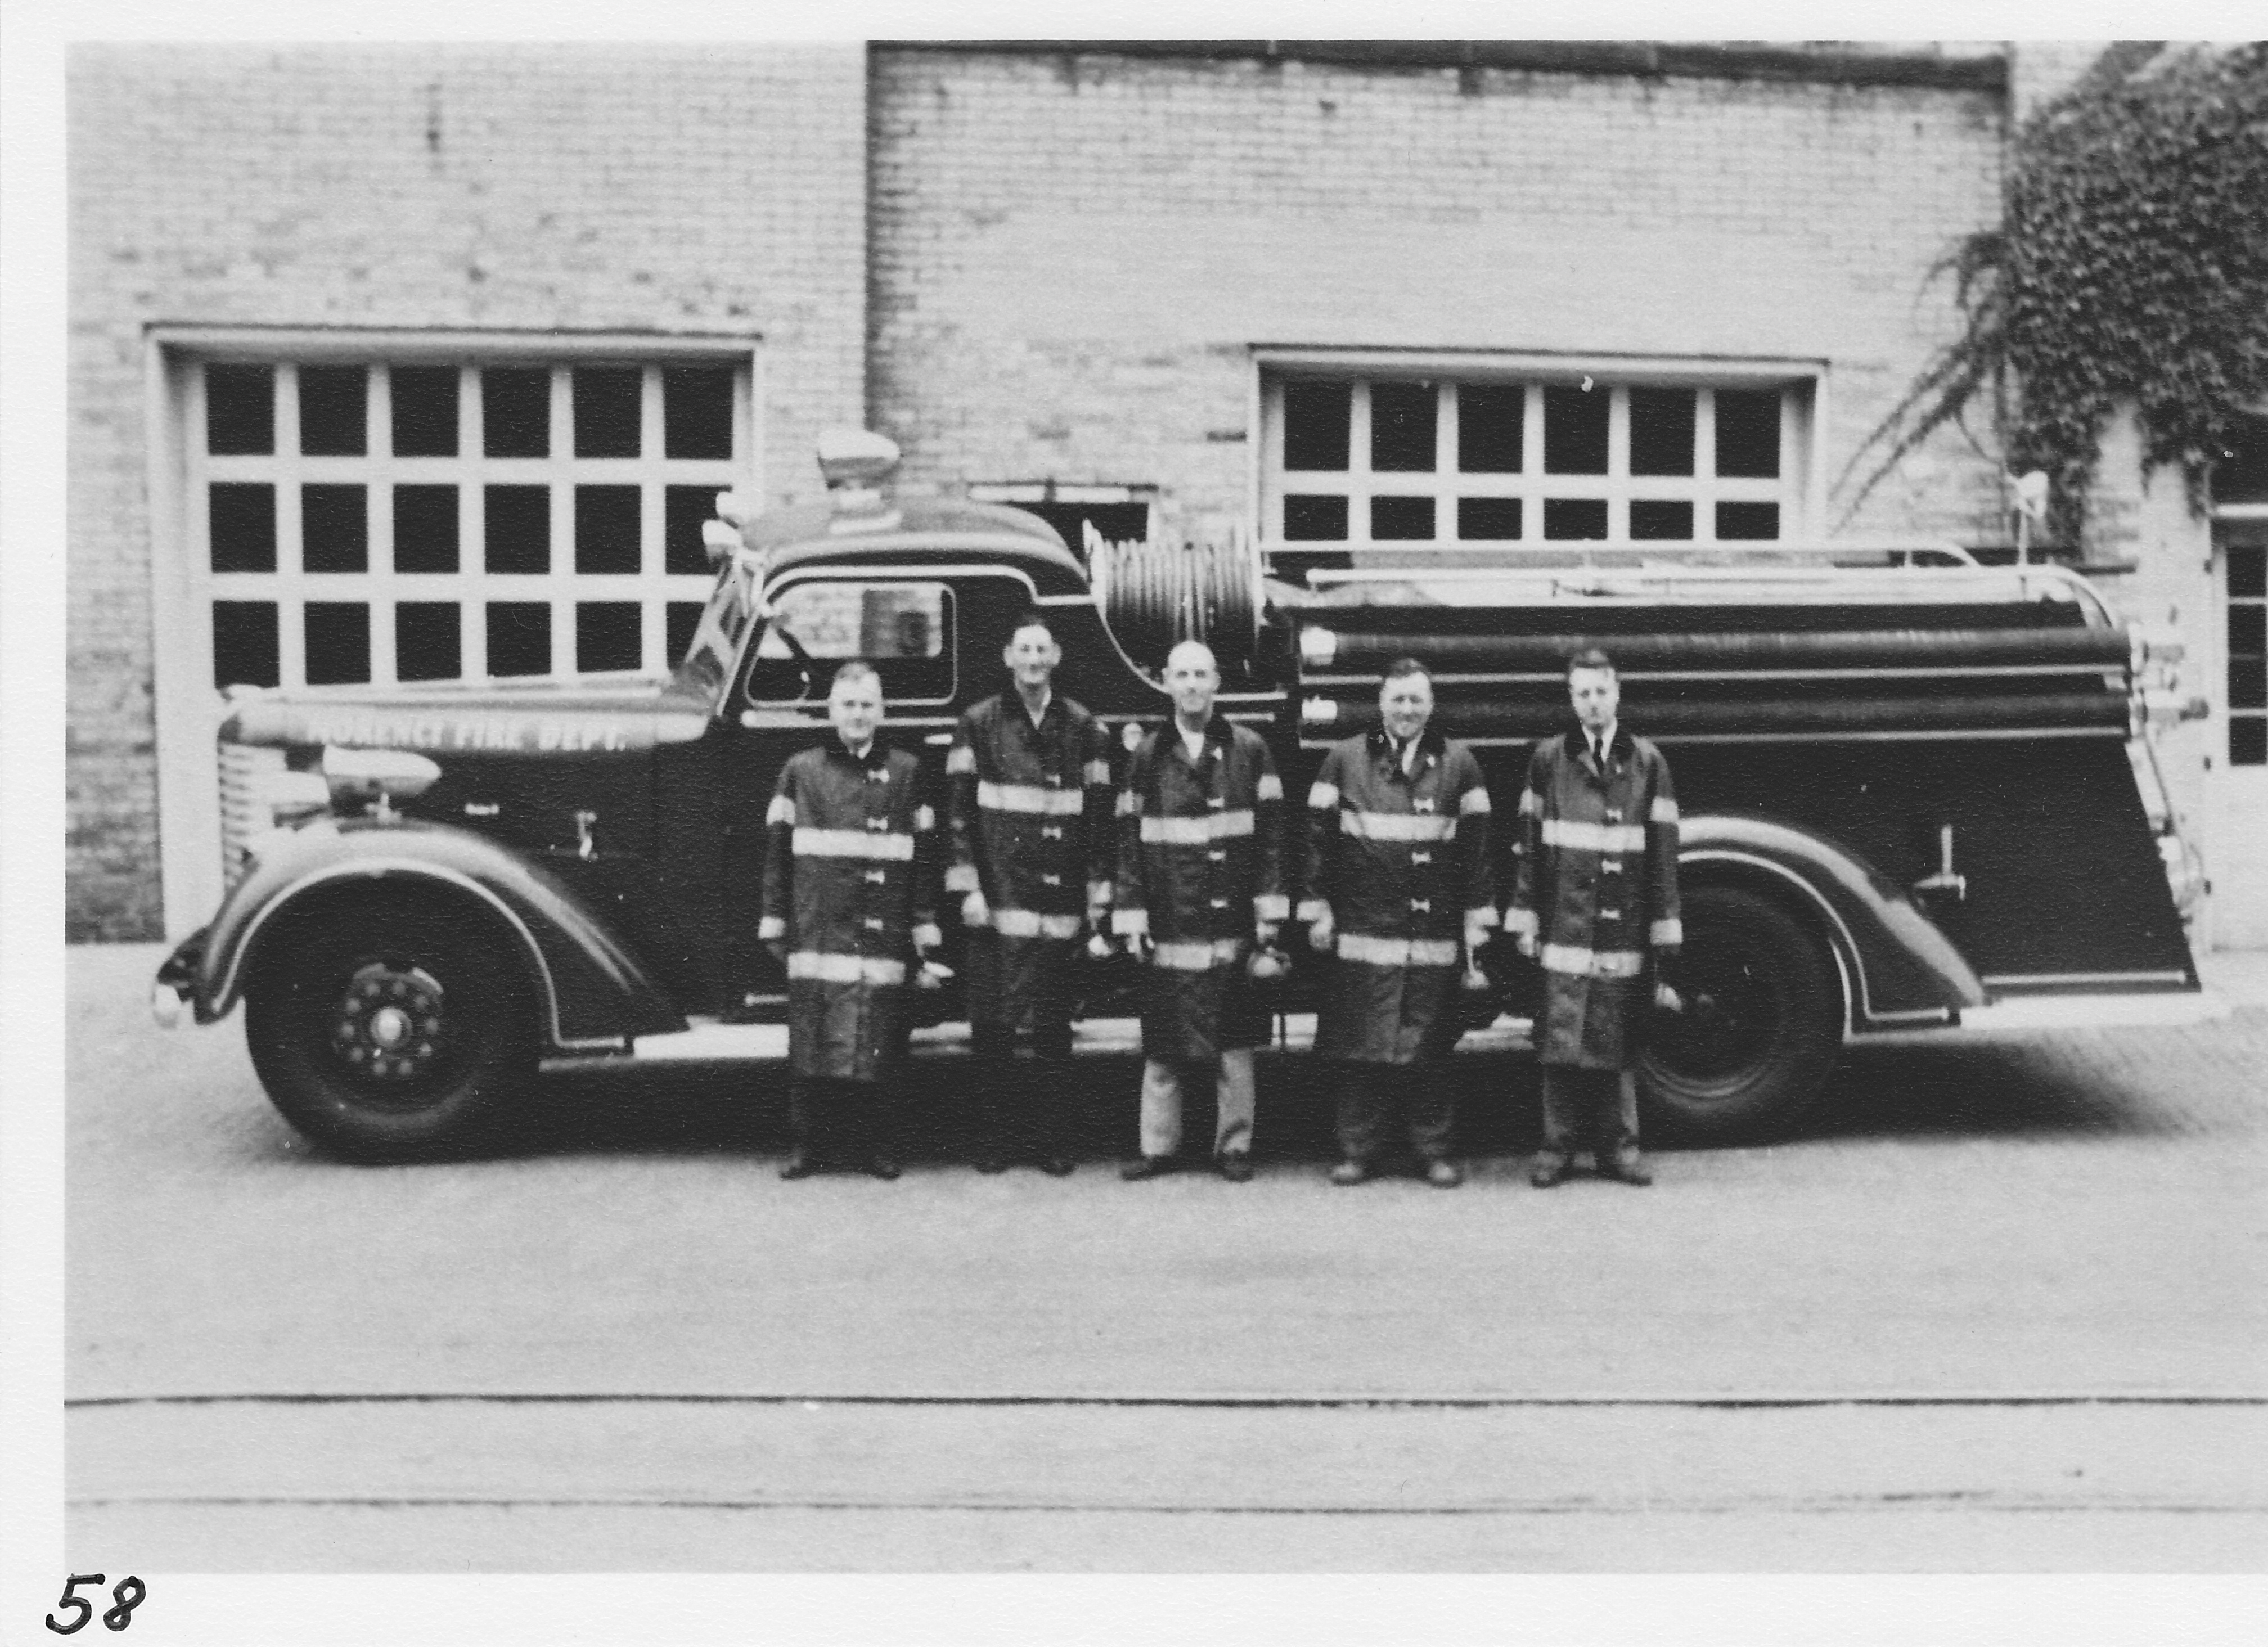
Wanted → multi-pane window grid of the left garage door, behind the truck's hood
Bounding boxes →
[182,356,755,687]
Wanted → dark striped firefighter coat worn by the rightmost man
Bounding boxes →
[1504,726,1685,1069]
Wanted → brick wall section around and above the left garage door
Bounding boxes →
[66,46,866,939]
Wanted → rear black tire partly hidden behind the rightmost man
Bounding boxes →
[1637,887,1842,1144]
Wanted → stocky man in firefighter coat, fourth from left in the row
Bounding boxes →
[1299,658,1497,1189]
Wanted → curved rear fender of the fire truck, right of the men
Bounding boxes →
[1678,812,1984,1030]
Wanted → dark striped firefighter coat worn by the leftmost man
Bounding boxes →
[758,740,941,1080]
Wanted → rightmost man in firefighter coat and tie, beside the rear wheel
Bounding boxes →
[1504,646,1685,1189]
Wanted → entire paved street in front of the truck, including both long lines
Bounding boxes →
[66,946,2268,1572]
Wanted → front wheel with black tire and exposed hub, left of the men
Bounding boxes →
[245,898,536,1162]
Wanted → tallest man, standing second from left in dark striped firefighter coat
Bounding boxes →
[946,610,1116,1177]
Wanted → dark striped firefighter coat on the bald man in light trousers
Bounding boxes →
[1112,714,1290,1064]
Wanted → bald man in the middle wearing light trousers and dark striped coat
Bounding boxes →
[1112,640,1290,1184]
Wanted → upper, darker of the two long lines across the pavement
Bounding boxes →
[64,1390,2268,1411]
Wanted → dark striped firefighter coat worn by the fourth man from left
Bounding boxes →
[1299,728,1497,1064]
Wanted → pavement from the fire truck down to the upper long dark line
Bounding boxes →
[66,946,2268,1400]
